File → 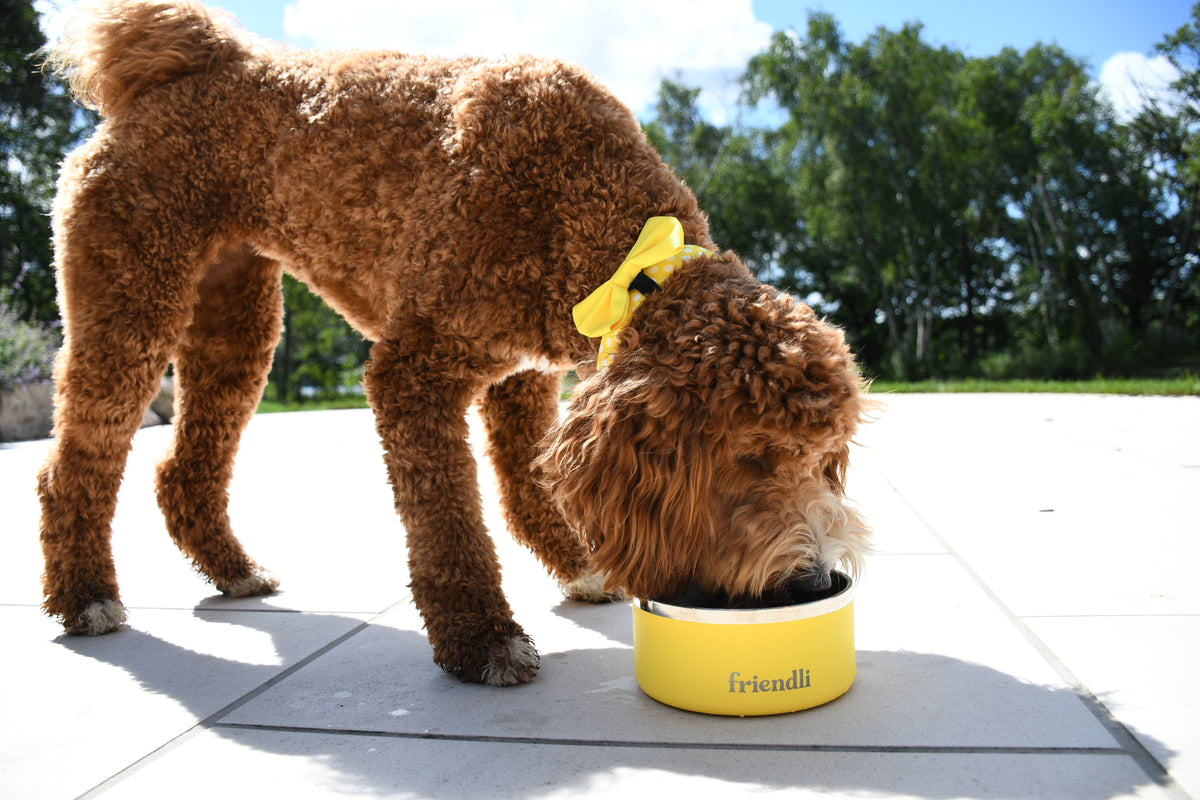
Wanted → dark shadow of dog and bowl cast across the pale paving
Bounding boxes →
[58,602,1174,800]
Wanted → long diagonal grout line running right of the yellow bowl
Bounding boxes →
[883,475,1190,800]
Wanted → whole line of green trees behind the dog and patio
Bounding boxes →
[0,0,1200,401]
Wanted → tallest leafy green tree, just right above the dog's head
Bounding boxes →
[746,13,971,377]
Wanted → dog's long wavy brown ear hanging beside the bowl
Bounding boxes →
[539,368,715,597]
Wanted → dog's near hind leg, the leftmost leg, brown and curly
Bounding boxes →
[37,211,199,634]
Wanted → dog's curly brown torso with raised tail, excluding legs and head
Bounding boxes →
[52,0,712,345]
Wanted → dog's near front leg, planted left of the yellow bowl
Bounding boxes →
[364,337,539,686]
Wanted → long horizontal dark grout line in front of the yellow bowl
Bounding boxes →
[201,722,1128,756]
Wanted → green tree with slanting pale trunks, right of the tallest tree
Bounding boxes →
[971,44,1117,372]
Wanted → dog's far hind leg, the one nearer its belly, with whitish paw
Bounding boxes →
[156,246,283,597]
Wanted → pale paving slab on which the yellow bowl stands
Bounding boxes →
[213,557,1117,751]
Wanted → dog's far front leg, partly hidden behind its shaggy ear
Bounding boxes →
[481,371,612,601]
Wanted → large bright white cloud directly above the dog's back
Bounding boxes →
[283,0,770,122]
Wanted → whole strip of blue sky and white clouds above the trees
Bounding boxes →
[36,0,1192,125]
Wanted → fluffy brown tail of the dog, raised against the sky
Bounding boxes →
[46,0,251,116]
